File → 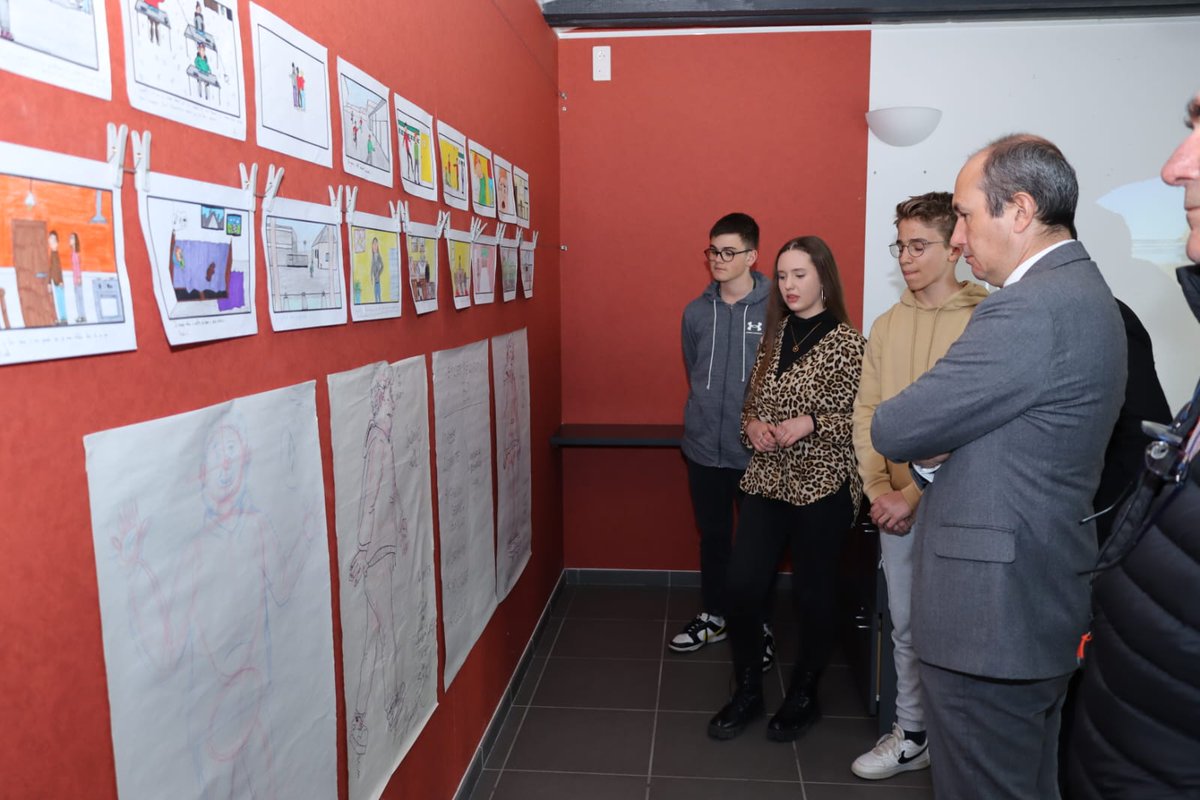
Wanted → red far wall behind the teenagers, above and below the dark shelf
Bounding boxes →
[558,31,870,569]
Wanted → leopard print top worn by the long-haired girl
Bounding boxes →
[742,324,865,519]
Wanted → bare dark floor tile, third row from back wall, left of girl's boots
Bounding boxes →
[532,658,659,711]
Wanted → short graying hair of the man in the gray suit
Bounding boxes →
[979,133,1079,236]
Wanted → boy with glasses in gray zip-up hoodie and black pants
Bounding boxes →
[667,213,774,669]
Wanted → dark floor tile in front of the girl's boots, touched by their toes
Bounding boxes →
[652,711,799,794]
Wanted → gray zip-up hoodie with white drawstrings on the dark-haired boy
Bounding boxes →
[683,271,773,469]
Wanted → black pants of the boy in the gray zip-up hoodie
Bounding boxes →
[684,458,743,616]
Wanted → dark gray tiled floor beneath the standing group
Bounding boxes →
[470,587,932,800]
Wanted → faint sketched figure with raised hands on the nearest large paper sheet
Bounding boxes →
[112,421,317,800]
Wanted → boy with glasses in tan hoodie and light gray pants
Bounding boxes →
[851,192,988,780]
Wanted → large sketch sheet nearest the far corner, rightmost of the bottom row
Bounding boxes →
[492,327,533,600]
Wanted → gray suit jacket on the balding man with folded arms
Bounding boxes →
[871,242,1126,679]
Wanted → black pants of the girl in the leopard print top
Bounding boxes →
[728,485,854,674]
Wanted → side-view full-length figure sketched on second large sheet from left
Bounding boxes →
[349,366,409,766]
